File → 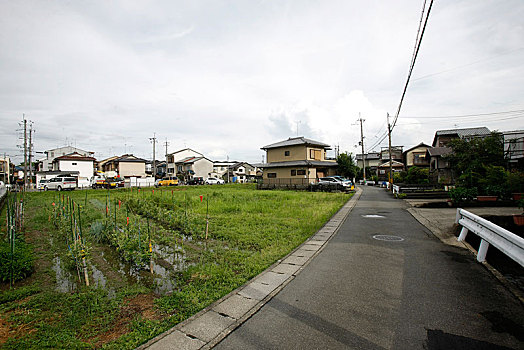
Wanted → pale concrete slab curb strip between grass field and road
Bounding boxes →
[137,188,362,350]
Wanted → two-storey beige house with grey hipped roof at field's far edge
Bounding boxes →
[260,137,338,185]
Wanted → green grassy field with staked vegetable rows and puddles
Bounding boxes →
[0,185,350,349]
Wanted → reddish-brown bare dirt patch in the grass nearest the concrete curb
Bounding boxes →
[93,294,163,347]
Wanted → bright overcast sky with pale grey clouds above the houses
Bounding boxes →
[0,0,524,163]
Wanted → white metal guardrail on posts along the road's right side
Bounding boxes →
[455,208,524,267]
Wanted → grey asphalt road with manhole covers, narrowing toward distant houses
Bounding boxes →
[215,187,524,350]
